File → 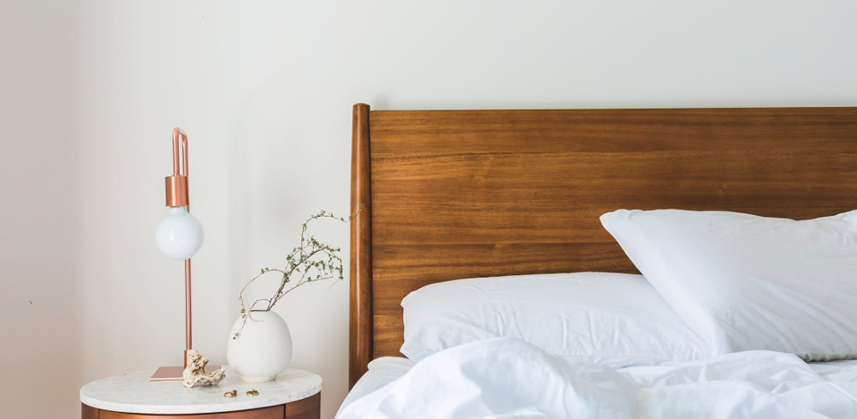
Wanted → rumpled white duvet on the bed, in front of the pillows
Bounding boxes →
[337,338,857,419]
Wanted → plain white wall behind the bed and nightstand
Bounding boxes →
[0,0,857,418]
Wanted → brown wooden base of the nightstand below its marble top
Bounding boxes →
[80,393,321,419]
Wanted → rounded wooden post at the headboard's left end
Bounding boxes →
[348,103,372,389]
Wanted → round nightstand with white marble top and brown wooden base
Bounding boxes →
[80,367,321,419]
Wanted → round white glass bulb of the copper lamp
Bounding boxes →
[155,207,205,260]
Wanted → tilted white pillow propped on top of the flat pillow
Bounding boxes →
[601,210,857,361]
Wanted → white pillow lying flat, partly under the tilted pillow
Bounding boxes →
[401,272,710,368]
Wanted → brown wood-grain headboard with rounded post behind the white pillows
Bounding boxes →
[349,104,857,385]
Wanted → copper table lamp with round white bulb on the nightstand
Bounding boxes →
[151,128,214,381]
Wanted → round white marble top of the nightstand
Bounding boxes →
[80,366,321,414]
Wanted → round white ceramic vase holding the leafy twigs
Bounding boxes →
[226,311,292,383]
